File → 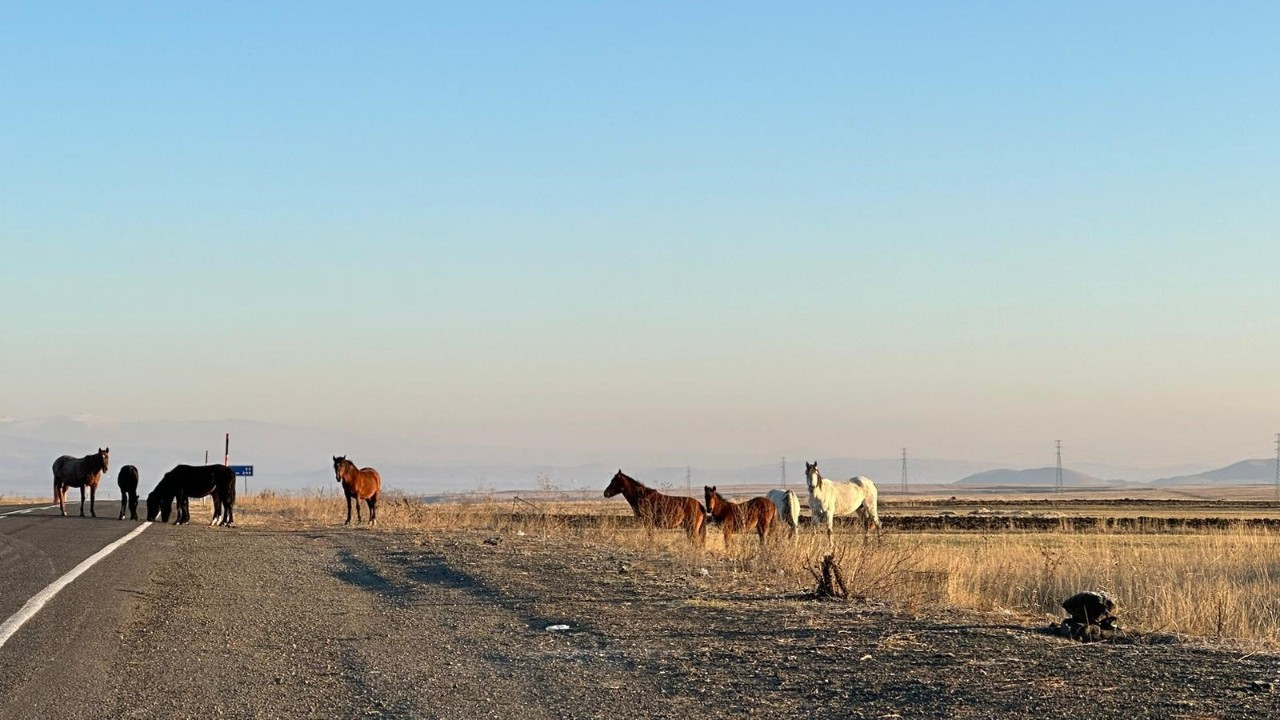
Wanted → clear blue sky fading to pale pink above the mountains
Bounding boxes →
[0,3,1280,464]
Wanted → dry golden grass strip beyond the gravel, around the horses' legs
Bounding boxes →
[227,493,1280,648]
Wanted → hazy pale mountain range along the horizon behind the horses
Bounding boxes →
[0,416,1275,497]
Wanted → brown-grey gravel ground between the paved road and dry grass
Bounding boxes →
[92,527,1280,719]
